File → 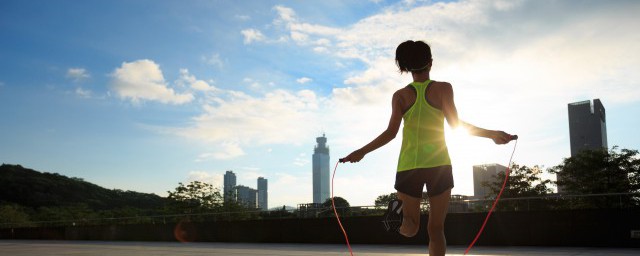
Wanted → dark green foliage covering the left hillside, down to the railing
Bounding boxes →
[0,164,167,226]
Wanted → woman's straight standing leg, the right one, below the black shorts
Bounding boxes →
[428,189,451,256]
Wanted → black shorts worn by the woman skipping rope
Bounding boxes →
[394,165,453,198]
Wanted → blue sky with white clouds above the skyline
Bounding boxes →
[0,0,640,207]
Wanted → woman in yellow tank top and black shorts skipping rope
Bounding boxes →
[340,40,512,255]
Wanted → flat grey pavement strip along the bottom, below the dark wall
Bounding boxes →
[0,240,640,256]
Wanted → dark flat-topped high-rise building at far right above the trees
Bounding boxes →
[569,99,608,156]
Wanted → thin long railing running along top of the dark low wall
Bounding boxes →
[0,193,640,228]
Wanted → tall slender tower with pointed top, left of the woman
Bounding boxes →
[312,134,330,204]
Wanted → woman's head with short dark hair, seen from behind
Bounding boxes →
[396,40,432,73]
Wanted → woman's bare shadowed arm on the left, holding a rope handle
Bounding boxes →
[340,91,402,163]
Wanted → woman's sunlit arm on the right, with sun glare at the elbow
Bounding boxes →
[439,83,511,144]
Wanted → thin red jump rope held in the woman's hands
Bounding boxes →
[331,135,518,256]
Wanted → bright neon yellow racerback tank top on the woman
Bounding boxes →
[398,80,451,172]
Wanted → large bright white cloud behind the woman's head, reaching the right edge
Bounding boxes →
[264,1,640,140]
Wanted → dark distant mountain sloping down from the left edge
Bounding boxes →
[0,164,167,210]
